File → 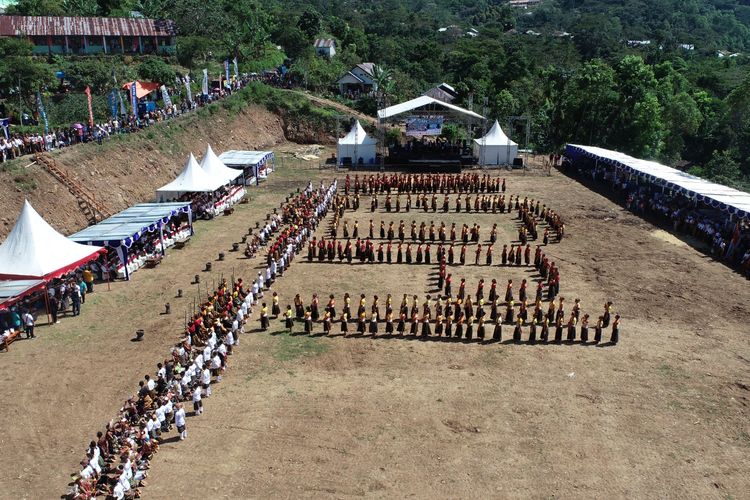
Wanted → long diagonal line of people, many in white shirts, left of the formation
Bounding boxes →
[67,181,337,500]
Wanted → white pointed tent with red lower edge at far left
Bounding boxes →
[0,201,105,280]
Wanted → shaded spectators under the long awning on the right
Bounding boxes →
[563,161,750,277]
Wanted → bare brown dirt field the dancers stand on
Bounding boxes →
[0,165,750,498]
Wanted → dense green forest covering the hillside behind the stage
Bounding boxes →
[0,0,750,188]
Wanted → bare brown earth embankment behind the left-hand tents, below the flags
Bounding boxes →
[0,85,335,237]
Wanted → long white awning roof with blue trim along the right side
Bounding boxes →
[565,144,750,217]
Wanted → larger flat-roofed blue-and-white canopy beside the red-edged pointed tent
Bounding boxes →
[68,202,193,279]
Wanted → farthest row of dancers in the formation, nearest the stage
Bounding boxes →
[344,172,506,195]
